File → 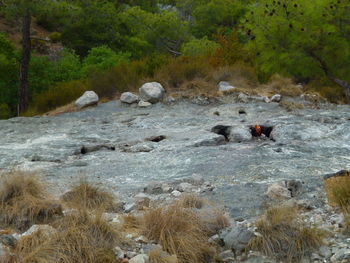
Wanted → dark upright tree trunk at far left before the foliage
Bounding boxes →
[19,9,31,114]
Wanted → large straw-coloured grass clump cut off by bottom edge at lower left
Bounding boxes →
[13,212,121,263]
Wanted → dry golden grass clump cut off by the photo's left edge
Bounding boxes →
[0,172,62,230]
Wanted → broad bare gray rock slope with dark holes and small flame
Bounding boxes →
[0,101,350,219]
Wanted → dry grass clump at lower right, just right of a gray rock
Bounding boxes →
[249,207,324,262]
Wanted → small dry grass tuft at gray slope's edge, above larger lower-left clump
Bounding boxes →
[62,180,115,210]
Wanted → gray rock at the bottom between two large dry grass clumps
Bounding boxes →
[223,226,254,253]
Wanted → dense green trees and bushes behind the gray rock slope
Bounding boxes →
[0,0,350,118]
